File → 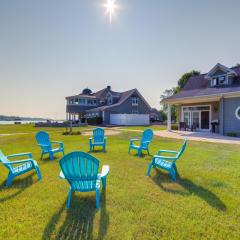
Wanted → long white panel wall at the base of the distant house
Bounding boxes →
[110,114,150,126]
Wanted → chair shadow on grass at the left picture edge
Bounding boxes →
[0,172,36,202]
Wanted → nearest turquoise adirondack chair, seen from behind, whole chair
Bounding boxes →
[59,152,109,209]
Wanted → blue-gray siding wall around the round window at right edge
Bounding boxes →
[222,97,240,135]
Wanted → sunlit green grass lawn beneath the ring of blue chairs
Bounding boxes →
[0,125,240,240]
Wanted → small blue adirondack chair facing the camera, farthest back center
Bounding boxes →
[89,128,107,152]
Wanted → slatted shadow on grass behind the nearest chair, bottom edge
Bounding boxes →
[42,190,109,240]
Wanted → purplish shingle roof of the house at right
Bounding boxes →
[166,66,240,101]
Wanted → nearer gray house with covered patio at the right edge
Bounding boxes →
[165,63,240,135]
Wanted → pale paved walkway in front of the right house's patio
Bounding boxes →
[154,130,240,144]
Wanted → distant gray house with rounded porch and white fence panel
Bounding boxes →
[66,86,151,125]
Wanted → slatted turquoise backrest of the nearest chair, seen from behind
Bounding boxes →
[60,152,99,191]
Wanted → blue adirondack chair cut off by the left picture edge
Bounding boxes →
[0,150,42,187]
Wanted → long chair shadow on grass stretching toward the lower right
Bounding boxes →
[152,169,227,211]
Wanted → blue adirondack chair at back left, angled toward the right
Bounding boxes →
[36,131,64,160]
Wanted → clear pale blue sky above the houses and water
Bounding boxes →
[0,0,240,119]
